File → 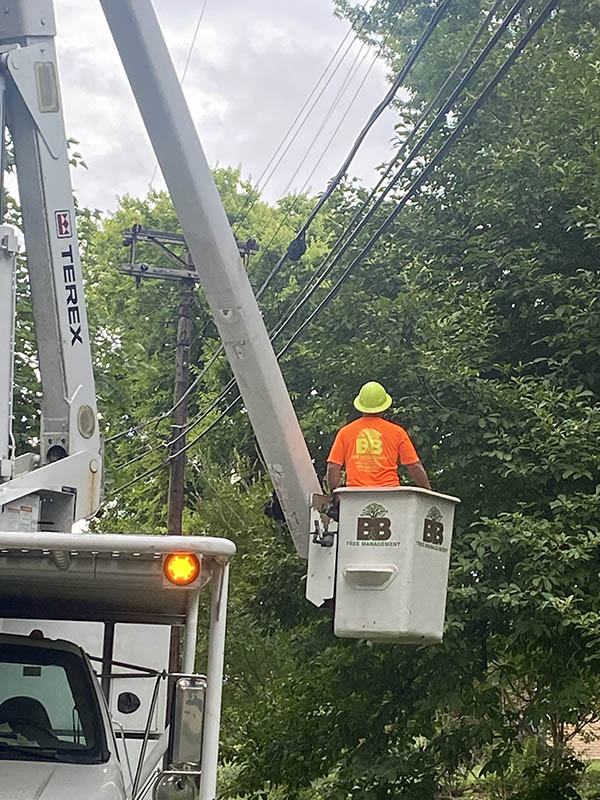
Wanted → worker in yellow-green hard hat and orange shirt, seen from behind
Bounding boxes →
[327,381,431,493]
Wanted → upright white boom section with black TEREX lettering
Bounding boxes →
[0,0,102,530]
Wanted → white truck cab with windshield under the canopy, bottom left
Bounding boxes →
[0,629,126,800]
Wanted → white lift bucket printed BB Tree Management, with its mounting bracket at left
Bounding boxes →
[307,487,460,644]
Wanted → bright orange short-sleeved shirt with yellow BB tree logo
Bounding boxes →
[327,417,419,486]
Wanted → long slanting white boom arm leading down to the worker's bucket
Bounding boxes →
[101,0,321,558]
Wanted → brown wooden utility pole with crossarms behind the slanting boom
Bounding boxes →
[121,225,258,535]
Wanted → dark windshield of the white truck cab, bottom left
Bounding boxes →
[0,643,106,764]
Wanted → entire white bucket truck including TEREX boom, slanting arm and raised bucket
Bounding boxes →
[0,0,456,800]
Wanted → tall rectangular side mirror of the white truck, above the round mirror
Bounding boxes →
[167,675,206,769]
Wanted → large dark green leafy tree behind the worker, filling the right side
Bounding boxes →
[205,2,600,798]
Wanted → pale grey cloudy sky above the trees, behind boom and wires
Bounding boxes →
[49,0,395,210]
